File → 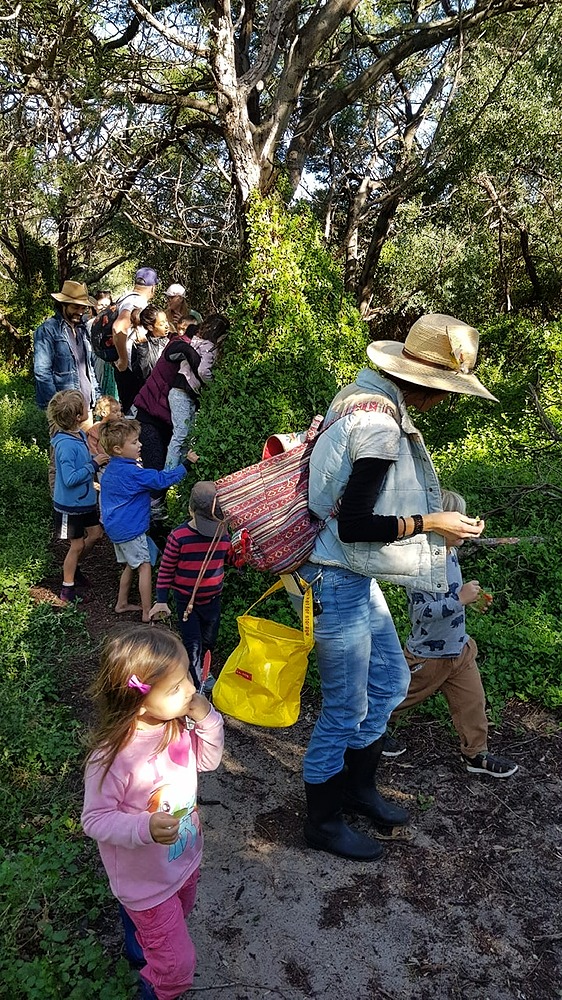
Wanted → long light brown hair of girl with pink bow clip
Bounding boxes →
[88,625,186,784]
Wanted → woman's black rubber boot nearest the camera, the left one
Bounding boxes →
[304,771,384,861]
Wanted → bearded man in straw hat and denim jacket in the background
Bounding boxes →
[33,281,99,411]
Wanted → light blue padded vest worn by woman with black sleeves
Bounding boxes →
[308,368,447,594]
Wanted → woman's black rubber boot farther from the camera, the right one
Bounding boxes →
[343,736,410,827]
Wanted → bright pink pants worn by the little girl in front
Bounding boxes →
[126,869,199,1000]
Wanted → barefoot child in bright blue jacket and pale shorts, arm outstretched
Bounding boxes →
[100,418,197,622]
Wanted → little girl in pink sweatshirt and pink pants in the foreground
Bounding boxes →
[82,625,224,1000]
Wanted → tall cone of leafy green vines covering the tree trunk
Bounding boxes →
[190,192,369,479]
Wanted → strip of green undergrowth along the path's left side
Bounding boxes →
[0,372,131,1000]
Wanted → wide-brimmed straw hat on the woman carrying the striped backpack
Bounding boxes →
[367,313,498,403]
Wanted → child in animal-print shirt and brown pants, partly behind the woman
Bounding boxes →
[383,490,518,778]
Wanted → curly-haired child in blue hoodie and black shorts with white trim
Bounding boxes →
[47,389,107,603]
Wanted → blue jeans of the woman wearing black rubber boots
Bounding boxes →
[299,563,410,784]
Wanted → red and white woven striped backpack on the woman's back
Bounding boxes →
[215,398,396,573]
